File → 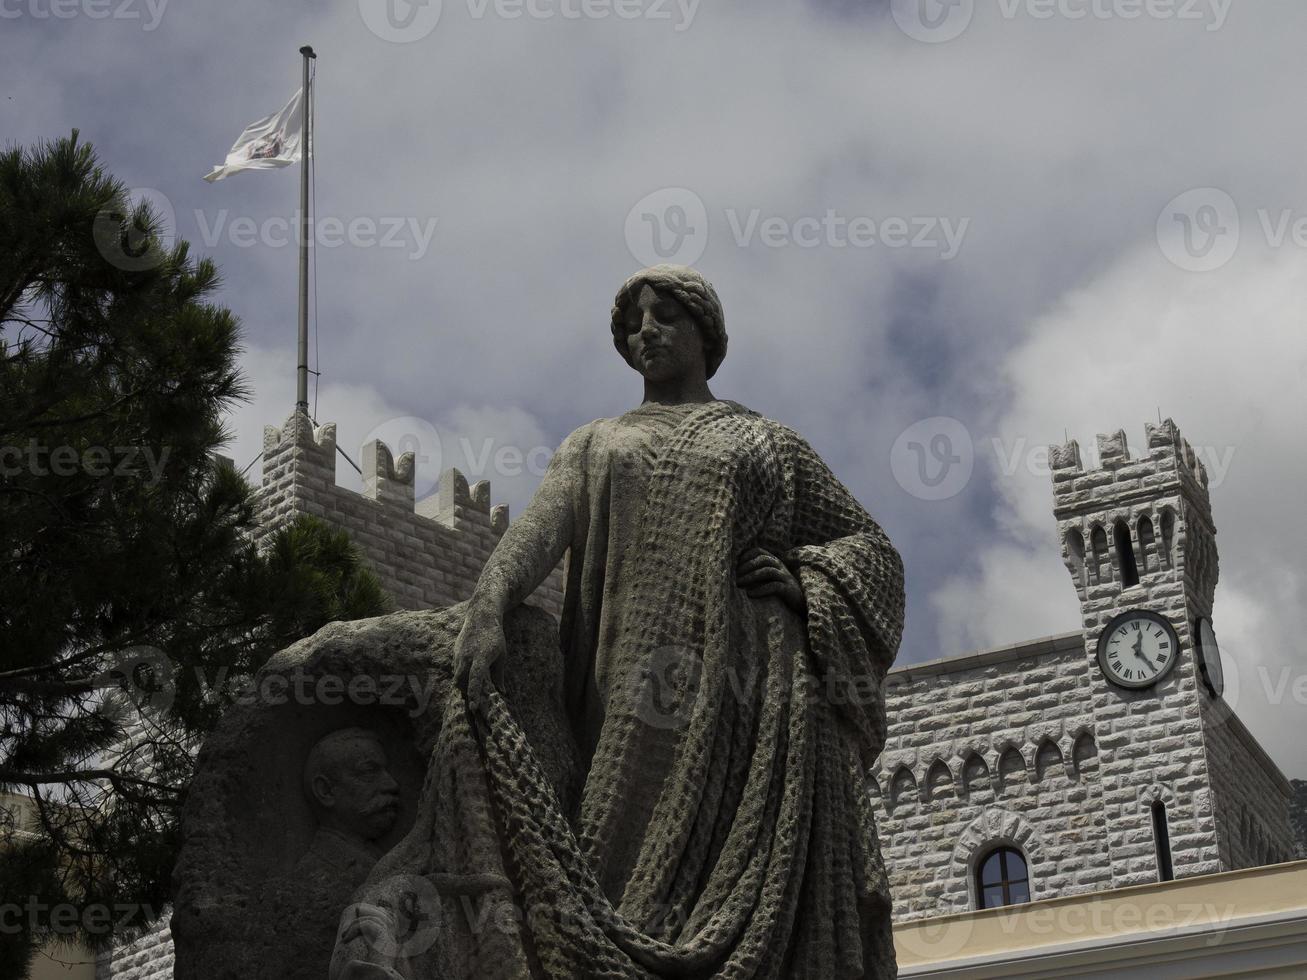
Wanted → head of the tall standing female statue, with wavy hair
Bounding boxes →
[612,265,727,379]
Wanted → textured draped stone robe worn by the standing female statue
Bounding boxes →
[336,401,903,980]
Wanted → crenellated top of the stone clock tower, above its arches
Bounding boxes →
[1048,418,1212,528]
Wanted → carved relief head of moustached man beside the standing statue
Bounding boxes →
[303,728,400,841]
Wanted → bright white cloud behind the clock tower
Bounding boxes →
[933,248,1307,775]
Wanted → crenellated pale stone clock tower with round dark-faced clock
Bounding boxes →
[1050,419,1228,887]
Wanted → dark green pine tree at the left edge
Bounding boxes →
[0,131,387,976]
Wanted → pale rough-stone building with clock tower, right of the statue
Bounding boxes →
[870,421,1295,920]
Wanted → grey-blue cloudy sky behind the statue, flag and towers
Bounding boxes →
[0,0,1307,776]
